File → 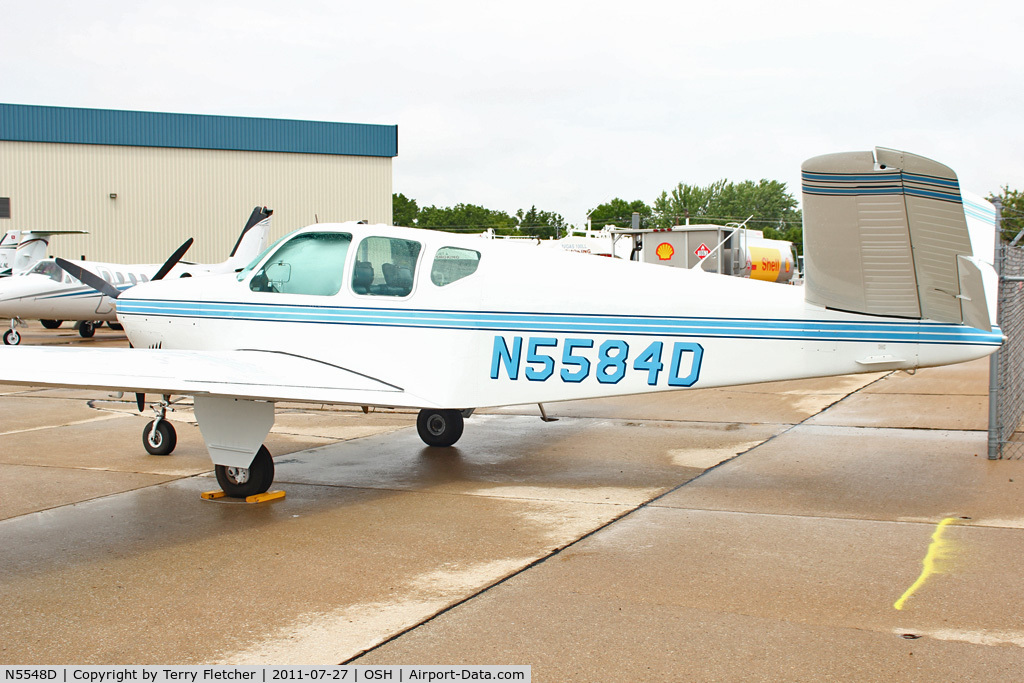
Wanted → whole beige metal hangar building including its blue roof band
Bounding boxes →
[0,103,398,263]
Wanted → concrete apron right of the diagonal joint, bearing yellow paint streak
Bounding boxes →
[353,362,1024,681]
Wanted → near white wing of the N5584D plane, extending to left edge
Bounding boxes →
[0,346,434,408]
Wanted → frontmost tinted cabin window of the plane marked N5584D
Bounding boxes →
[249,232,352,296]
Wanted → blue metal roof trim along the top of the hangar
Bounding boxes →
[0,103,398,157]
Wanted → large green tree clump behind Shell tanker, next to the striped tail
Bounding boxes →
[650,179,804,252]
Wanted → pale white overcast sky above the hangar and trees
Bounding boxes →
[0,0,1024,224]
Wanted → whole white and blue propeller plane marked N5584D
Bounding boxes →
[0,148,1002,497]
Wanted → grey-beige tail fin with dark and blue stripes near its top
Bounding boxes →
[802,147,995,331]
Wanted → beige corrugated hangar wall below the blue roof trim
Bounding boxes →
[0,141,391,263]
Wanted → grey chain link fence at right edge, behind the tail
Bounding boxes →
[988,245,1024,460]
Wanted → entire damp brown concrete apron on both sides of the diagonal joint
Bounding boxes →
[0,358,1024,680]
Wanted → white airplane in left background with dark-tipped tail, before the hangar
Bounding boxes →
[0,207,272,346]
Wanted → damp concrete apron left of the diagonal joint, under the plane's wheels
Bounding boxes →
[0,391,798,664]
